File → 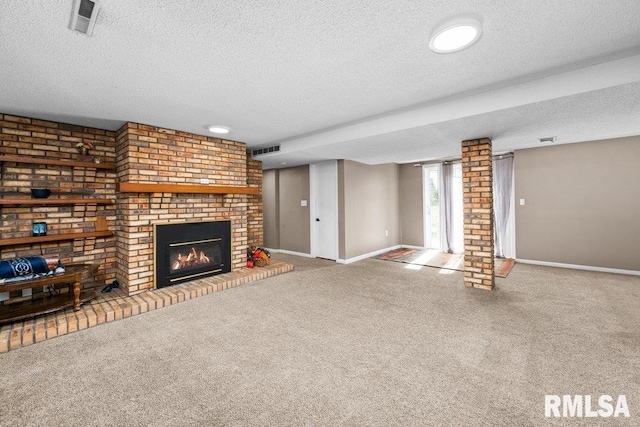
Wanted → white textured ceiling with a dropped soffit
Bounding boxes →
[0,0,640,168]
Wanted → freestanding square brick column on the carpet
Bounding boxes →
[462,138,494,290]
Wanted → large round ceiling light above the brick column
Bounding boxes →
[429,16,482,53]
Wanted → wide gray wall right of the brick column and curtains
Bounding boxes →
[514,137,640,271]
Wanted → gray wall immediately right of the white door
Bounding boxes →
[338,160,400,259]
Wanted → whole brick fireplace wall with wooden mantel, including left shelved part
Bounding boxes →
[0,114,263,304]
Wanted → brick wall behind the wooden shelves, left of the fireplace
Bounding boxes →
[0,114,116,302]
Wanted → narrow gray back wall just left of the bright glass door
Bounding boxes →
[399,165,424,246]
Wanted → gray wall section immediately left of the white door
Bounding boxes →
[274,166,311,254]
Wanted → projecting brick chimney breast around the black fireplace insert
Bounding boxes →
[116,123,262,295]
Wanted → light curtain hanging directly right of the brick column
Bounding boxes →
[493,156,513,258]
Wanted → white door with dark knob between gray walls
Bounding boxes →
[311,162,338,260]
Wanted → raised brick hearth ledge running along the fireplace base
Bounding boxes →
[0,260,293,353]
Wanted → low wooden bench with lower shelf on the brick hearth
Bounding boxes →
[0,264,98,324]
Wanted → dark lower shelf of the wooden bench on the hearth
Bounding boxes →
[0,289,96,324]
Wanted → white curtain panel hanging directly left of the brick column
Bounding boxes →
[442,163,464,253]
